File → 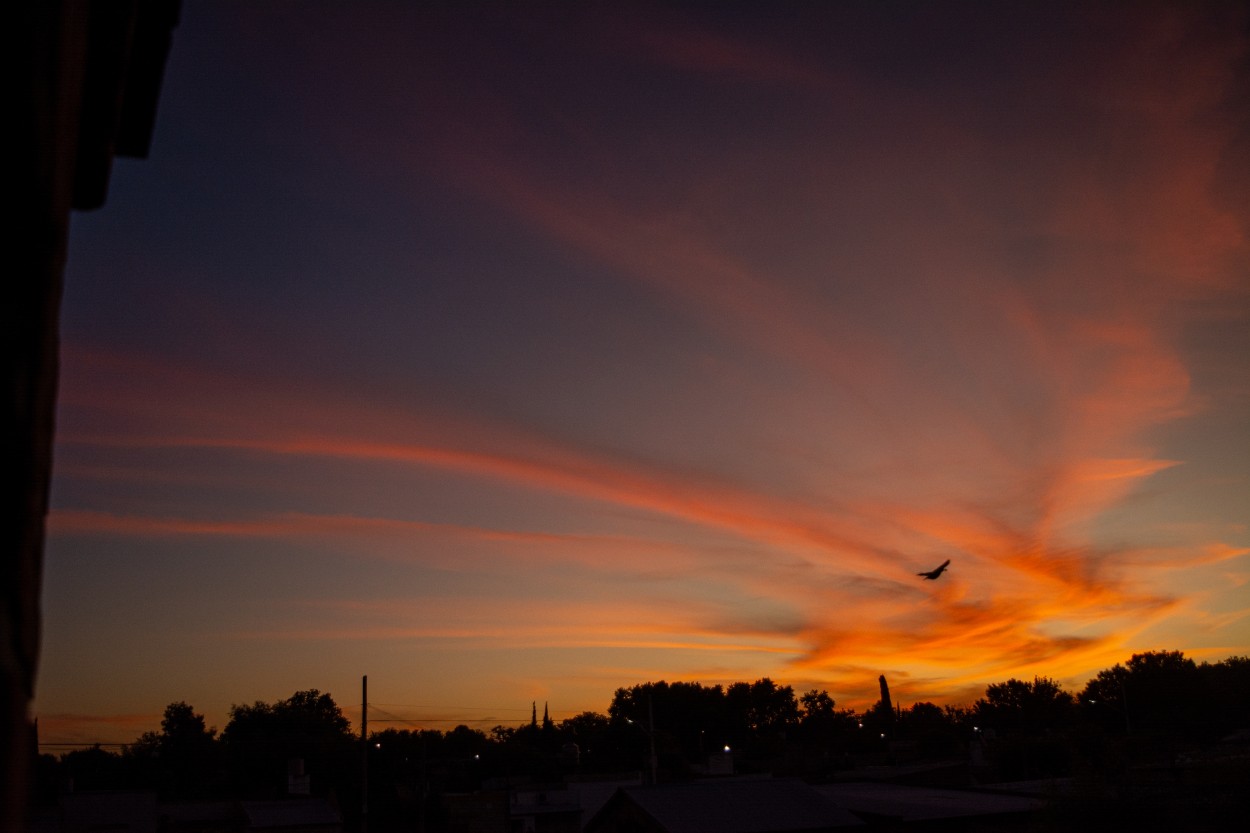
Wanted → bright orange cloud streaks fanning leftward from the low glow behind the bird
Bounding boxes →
[51,340,1200,690]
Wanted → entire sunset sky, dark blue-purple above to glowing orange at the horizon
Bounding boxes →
[36,1,1250,743]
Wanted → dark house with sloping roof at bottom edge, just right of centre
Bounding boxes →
[586,779,864,833]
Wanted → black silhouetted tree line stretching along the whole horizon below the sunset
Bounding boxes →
[36,652,1250,827]
